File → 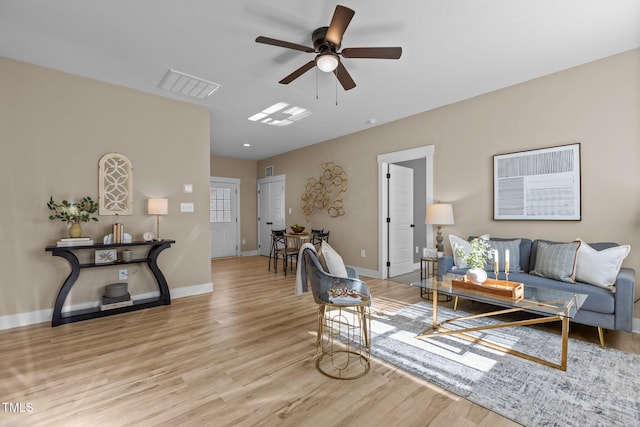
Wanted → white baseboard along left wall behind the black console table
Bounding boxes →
[0,282,213,330]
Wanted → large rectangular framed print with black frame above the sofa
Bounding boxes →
[493,143,582,221]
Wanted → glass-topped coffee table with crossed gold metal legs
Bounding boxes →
[411,274,587,371]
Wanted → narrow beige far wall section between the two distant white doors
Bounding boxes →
[210,156,258,252]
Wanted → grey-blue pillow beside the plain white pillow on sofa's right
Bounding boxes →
[529,241,580,283]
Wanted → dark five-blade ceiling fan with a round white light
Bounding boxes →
[256,5,402,90]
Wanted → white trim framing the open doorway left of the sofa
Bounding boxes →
[378,145,434,279]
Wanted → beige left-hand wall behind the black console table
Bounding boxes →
[0,58,211,323]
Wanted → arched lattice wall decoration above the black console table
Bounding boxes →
[98,153,133,215]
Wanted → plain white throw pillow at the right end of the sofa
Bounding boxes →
[576,239,631,291]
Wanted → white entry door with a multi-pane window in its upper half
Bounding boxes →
[209,179,239,258]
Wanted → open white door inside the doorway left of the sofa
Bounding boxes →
[387,164,413,277]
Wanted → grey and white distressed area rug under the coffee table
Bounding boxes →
[371,302,640,427]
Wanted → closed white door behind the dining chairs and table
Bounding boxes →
[258,175,285,256]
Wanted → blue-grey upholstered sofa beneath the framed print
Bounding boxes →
[438,236,635,347]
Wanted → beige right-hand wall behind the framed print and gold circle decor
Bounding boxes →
[258,49,640,276]
